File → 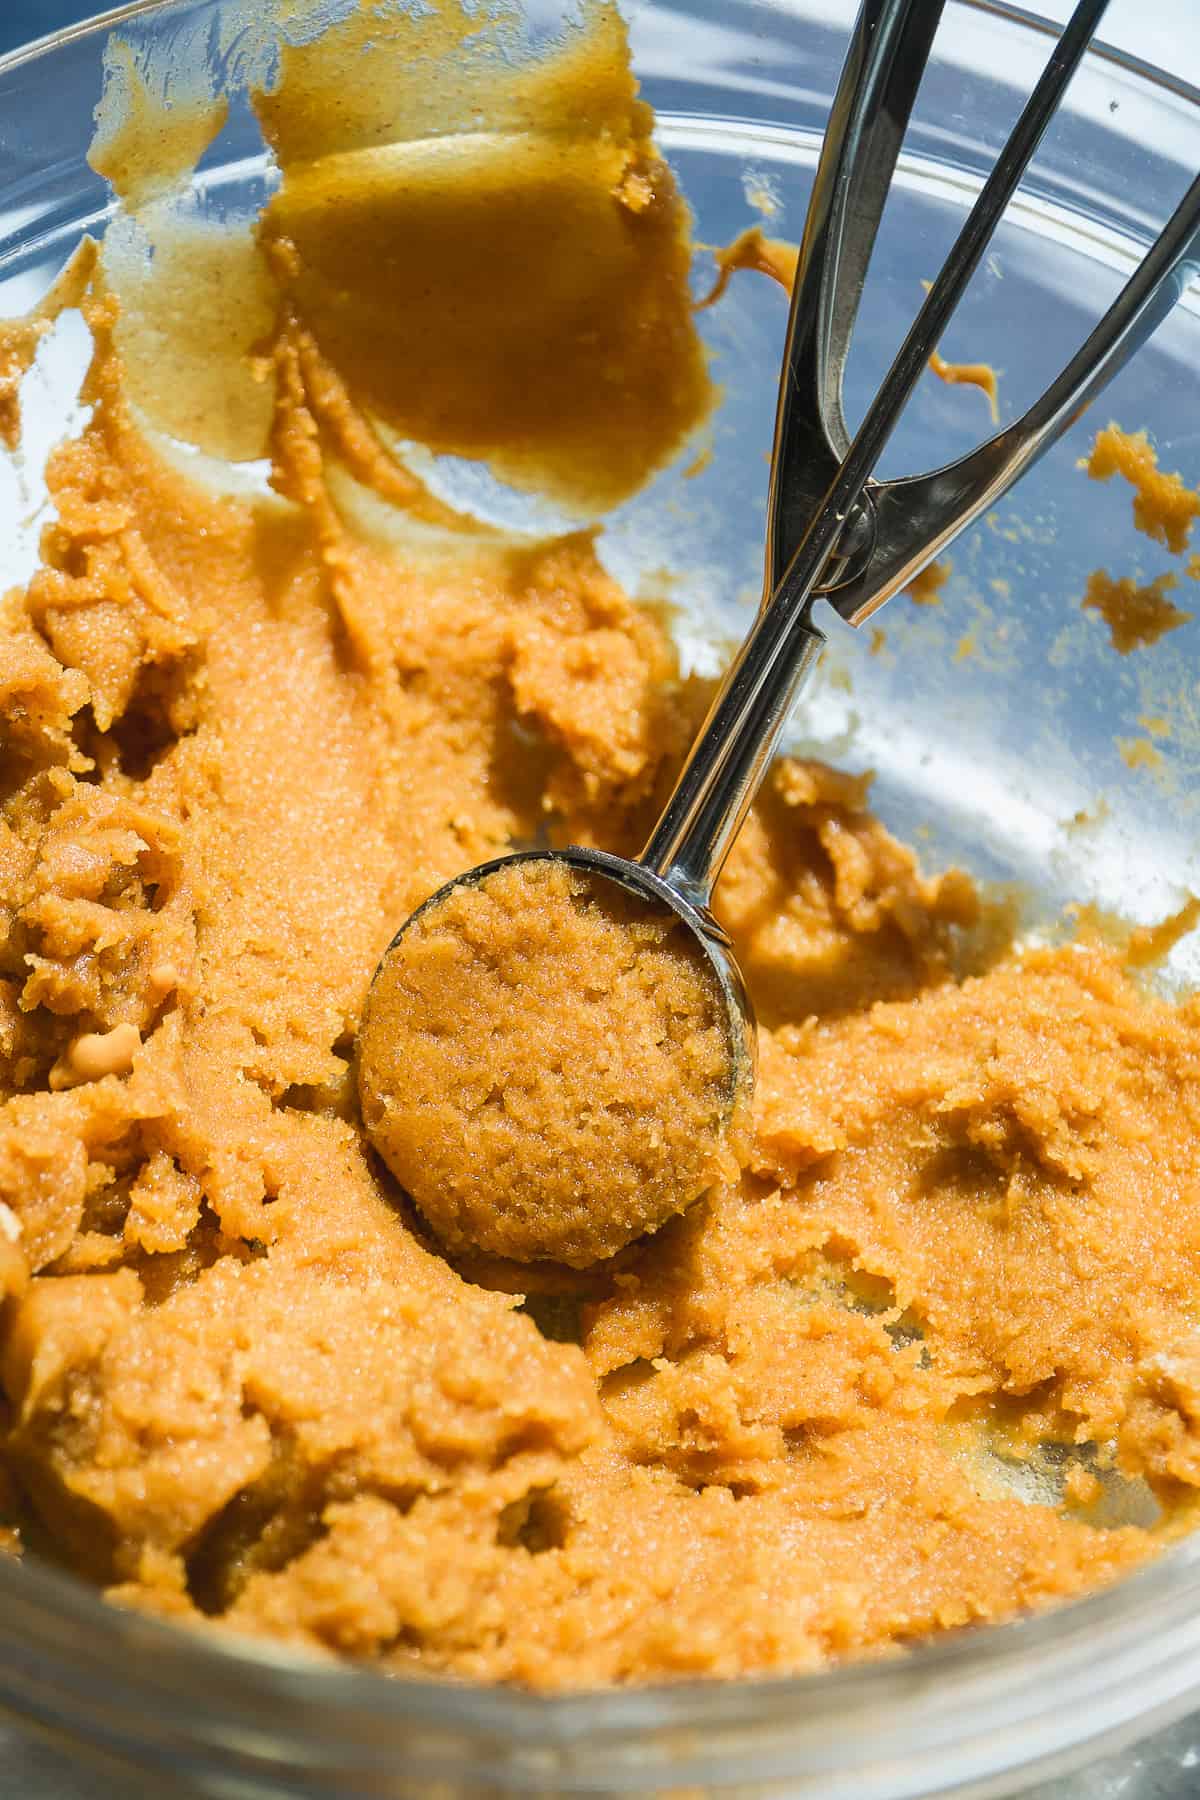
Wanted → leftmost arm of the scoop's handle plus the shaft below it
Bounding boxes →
[639,0,945,909]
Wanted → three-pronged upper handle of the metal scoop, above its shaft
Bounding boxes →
[780,0,1200,625]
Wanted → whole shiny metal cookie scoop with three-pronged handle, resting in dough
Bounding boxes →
[360,0,1200,1262]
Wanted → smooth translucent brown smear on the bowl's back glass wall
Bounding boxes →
[257,4,712,511]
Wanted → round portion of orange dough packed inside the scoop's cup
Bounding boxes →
[358,860,736,1267]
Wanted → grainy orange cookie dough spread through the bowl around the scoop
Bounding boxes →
[0,9,1200,1690]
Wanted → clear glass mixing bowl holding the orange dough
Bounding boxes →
[0,0,1200,1800]
